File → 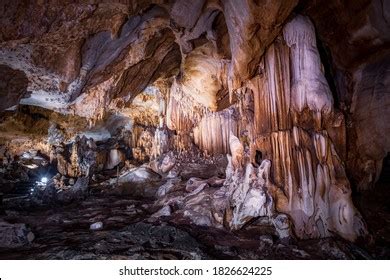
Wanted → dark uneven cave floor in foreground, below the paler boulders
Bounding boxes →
[0,188,388,259]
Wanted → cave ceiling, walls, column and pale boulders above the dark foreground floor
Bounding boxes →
[0,0,390,256]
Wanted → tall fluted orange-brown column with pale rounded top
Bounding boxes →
[219,16,366,240]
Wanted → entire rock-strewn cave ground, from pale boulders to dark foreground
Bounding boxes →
[0,149,390,259]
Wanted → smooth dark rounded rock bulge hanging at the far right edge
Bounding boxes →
[347,56,390,190]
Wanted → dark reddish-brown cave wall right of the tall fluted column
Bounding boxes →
[304,0,390,191]
